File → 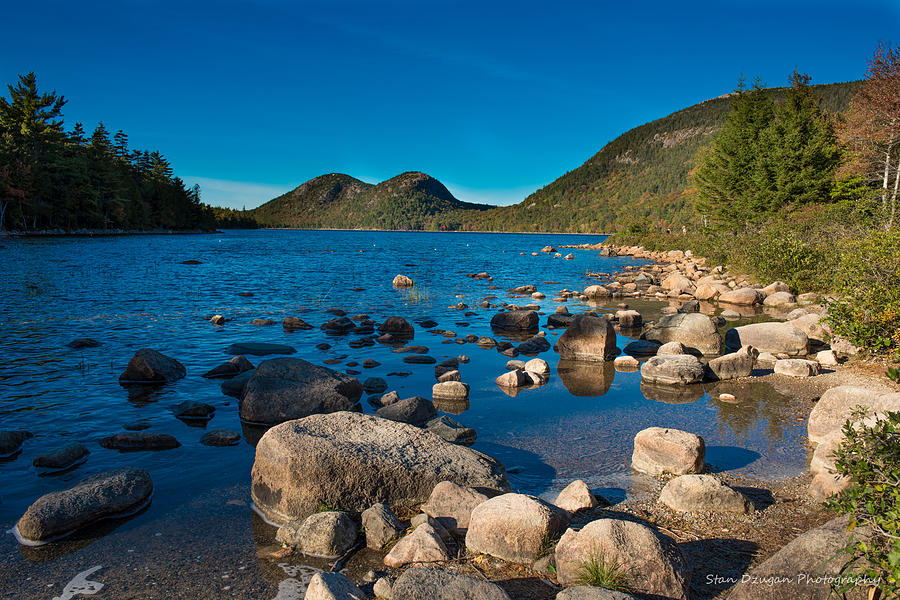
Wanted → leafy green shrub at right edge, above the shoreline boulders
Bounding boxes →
[828,231,900,353]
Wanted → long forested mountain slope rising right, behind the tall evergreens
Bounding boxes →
[458,82,859,233]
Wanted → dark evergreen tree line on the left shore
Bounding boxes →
[0,73,216,231]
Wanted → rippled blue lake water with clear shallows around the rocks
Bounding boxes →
[0,231,806,598]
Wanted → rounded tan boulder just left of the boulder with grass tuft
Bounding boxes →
[466,494,569,564]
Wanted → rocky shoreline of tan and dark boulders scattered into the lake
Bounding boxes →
[7,244,900,600]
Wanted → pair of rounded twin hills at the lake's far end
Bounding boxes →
[247,171,492,229]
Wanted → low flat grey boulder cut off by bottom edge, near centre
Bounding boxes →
[391,567,509,600]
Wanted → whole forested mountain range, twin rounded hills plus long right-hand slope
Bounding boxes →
[246,82,859,233]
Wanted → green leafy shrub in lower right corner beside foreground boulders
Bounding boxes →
[826,412,900,598]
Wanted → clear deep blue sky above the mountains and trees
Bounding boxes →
[0,0,900,208]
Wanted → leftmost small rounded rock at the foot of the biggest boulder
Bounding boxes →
[275,511,359,558]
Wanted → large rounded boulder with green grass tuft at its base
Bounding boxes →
[556,519,691,600]
